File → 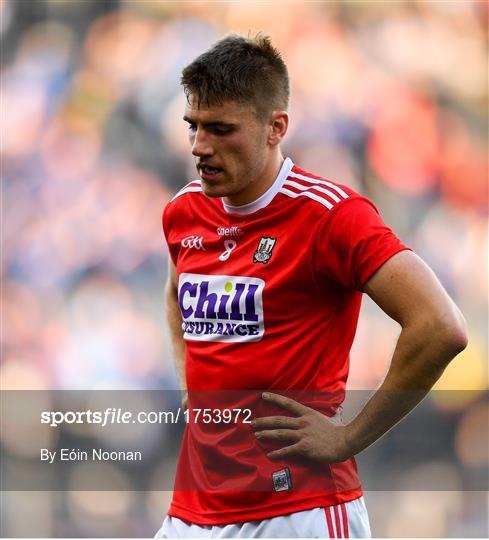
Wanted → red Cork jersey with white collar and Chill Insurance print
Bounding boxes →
[163,159,408,525]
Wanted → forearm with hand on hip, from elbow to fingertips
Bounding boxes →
[252,322,465,463]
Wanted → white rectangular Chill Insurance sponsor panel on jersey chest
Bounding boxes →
[178,274,265,342]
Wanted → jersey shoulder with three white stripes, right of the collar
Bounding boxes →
[280,165,377,219]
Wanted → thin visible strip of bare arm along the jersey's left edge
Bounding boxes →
[166,257,187,407]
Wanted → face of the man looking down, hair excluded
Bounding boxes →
[184,99,269,204]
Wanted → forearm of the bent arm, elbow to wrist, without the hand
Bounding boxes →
[345,326,464,455]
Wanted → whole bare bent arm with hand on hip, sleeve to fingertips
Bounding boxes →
[250,251,467,462]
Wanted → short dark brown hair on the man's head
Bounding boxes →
[181,34,290,118]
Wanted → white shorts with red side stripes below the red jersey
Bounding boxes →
[155,497,371,538]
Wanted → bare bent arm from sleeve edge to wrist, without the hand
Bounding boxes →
[347,251,467,454]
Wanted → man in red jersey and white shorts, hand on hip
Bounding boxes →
[157,36,467,538]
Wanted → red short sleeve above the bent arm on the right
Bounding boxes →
[314,197,410,290]
